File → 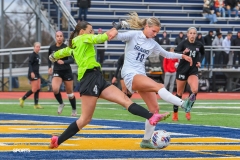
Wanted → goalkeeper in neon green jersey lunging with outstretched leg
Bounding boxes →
[49,21,169,149]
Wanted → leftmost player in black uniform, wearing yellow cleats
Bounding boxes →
[19,42,43,109]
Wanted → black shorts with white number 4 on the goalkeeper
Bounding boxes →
[79,68,111,97]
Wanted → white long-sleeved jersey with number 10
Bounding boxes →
[116,31,182,77]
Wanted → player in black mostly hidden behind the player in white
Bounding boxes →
[112,54,132,98]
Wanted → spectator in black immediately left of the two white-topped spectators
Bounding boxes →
[203,31,214,65]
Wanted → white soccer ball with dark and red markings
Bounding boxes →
[151,130,171,149]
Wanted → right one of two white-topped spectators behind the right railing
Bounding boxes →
[222,32,233,68]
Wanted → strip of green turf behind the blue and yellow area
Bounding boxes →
[0,99,240,128]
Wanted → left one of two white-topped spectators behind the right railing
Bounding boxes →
[212,32,223,68]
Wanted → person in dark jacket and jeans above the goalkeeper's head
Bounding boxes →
[77,0,91,21]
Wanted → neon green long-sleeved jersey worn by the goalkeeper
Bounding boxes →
[54,33,108,80]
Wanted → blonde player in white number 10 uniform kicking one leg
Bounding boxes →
[116,12,195,148]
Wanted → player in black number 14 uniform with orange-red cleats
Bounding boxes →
[172,27,205,121]
